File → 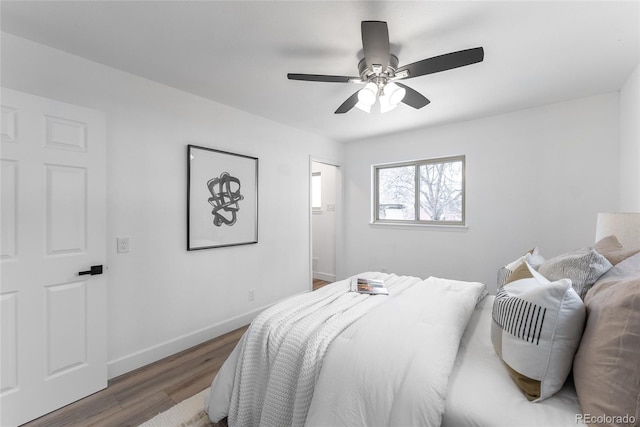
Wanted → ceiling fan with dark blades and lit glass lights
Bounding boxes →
[287,21,484,114]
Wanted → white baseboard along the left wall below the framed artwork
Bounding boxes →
[107,304,271,379]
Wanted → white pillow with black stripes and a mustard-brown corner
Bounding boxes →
[491,262,586,401]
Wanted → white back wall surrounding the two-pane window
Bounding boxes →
[345,93,619,290]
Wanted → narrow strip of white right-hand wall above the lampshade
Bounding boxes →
[620,64,640,212]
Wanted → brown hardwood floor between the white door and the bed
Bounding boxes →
[23,326,247,427]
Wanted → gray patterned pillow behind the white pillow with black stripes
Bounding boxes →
[538,248,613,300]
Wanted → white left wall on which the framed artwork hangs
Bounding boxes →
[2,33,342,377]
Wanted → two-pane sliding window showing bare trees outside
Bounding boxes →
[373,156,465,225]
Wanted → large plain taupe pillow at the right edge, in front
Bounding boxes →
[573,274,640,426]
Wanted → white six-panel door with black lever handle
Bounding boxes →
[0,88,107,427]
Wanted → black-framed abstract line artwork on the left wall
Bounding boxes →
[187,145,258,251]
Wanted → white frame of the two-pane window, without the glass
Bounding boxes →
[371,155,466,227]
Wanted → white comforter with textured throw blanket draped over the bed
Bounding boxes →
[207,273,485,427]
